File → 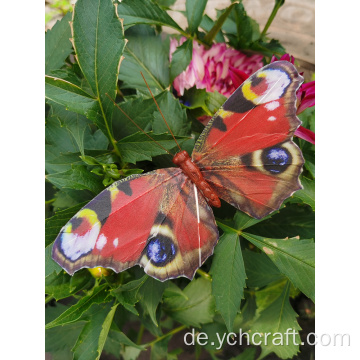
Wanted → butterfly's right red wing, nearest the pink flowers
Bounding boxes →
[192,61,304,218]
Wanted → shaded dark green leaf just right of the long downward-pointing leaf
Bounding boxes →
[243,249,284,288]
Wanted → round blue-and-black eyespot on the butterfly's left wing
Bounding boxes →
[146,235,176,266]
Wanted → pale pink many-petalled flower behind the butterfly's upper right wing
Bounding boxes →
[170,37,263,96]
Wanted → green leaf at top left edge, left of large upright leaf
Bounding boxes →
[45,12,72,74]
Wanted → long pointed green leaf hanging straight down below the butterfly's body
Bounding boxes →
[211,233,246,332]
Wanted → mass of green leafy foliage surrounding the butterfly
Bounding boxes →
[45,0,315,360]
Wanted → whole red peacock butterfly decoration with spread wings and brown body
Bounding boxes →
[52,61,304,281]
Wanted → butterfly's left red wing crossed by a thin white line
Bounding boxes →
[53,168,218,280]
